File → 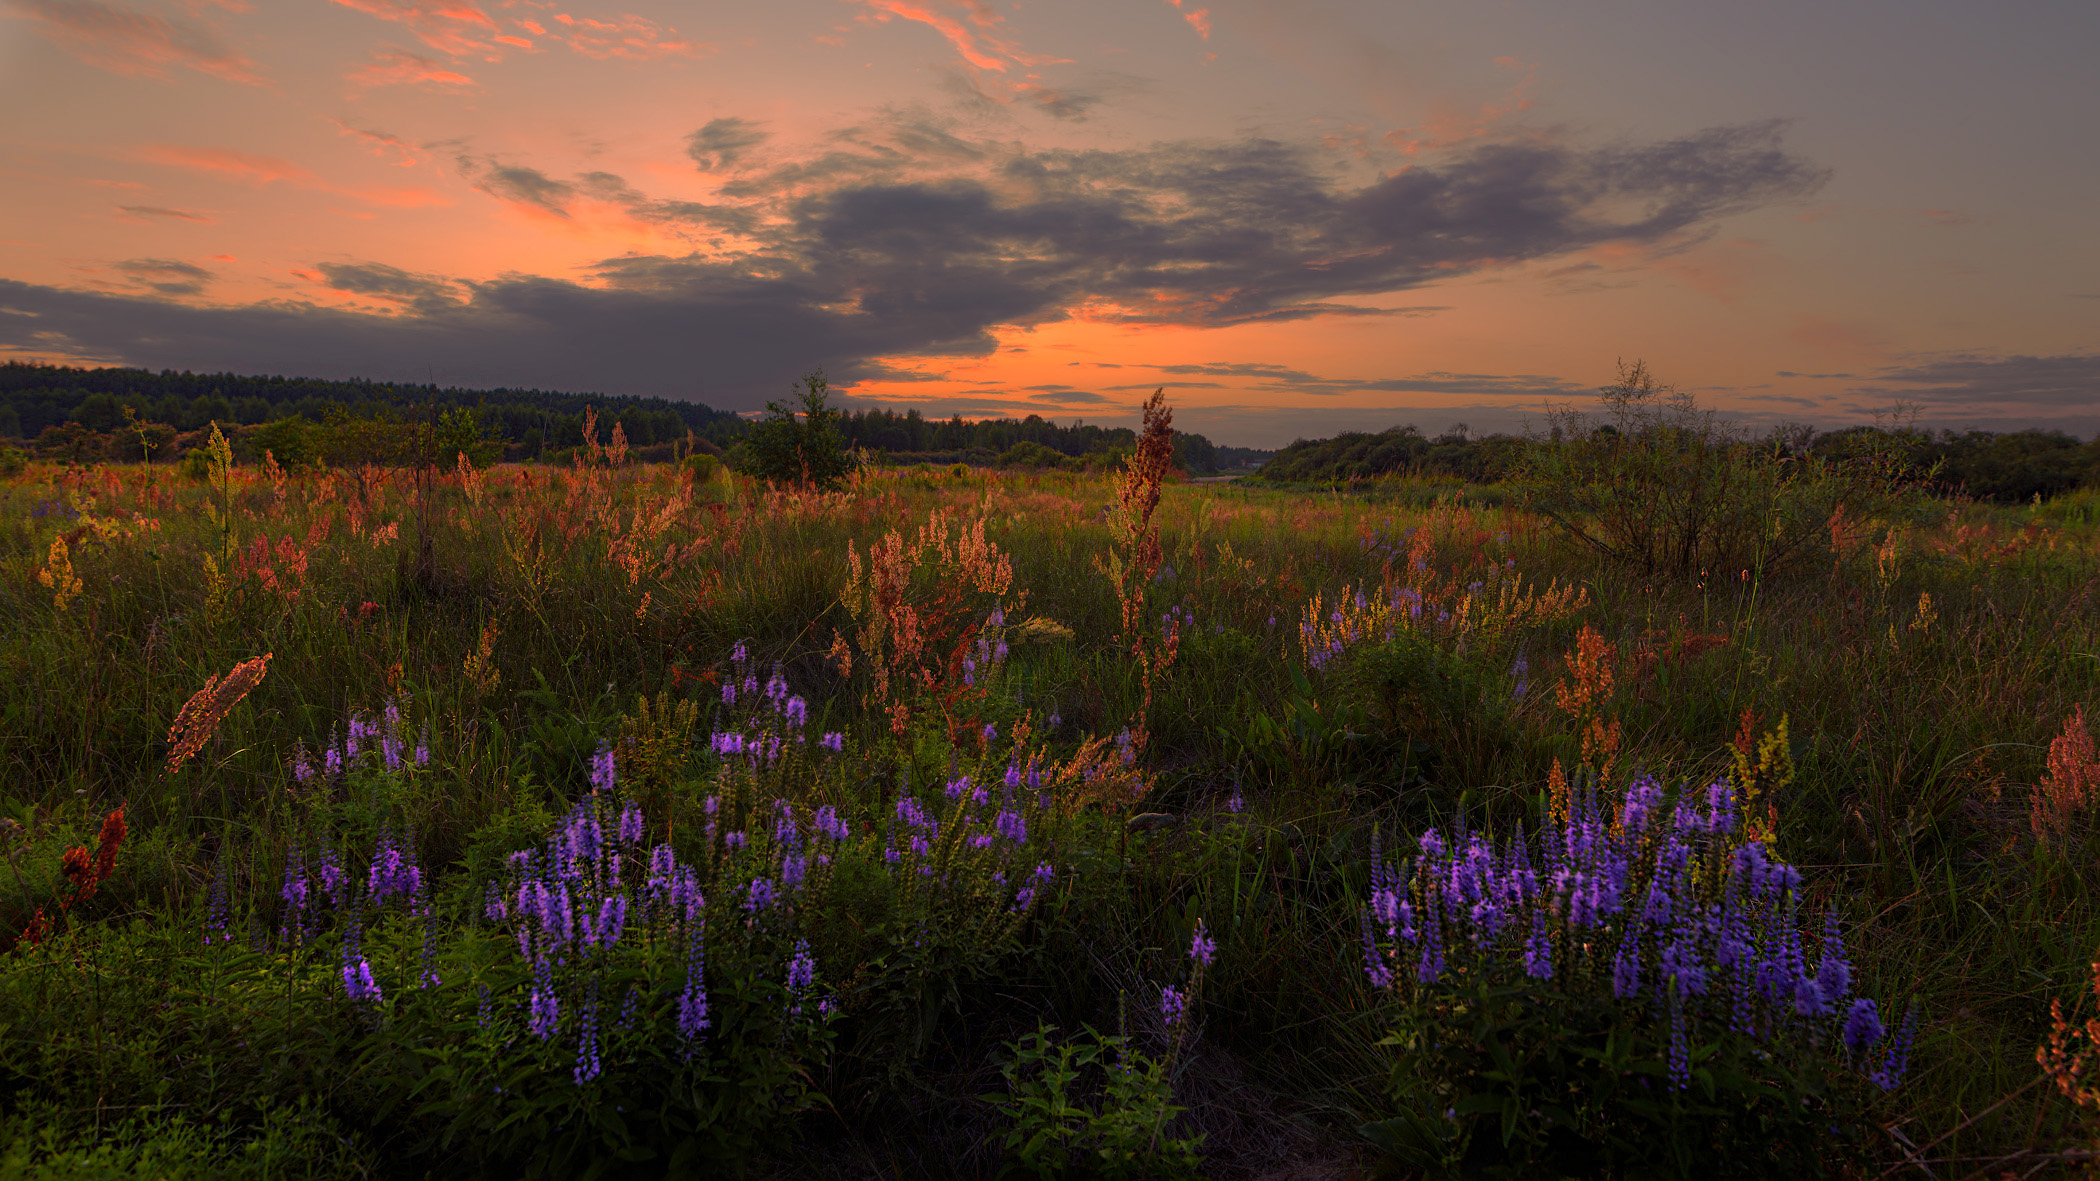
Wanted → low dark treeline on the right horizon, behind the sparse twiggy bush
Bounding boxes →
[1254,418,2100,502]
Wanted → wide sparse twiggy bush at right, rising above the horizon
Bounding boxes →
[1525,361,1907,580]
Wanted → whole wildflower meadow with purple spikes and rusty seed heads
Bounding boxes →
[0,422,2100,1177]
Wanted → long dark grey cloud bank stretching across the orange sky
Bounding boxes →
[0,116,1823,408]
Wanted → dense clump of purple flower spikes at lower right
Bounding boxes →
[1363,778,1915,1164]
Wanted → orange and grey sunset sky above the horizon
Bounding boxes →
[0,0,2100,448]
